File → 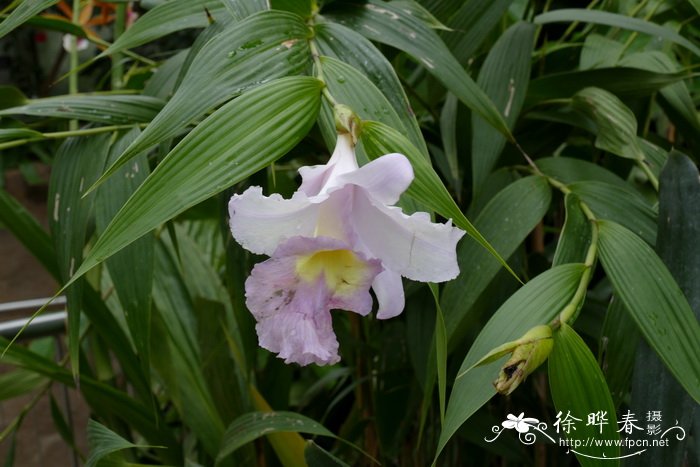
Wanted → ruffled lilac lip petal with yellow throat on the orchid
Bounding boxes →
[246,237,382,365]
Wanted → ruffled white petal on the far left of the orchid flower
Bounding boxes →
[228,186,319,256]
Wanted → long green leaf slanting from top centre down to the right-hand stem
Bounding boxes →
[324,0,513,141]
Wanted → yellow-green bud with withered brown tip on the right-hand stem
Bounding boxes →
[493,325,554,395]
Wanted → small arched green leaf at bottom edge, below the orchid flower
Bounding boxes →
[216,412,335,464]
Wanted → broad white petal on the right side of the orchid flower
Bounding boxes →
[353,193,464,282]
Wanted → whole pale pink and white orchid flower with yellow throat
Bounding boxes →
[229,134,464,365]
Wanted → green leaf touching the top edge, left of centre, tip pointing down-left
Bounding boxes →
[101,0,228,56]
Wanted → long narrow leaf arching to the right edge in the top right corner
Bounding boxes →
[535,8,700,56]
